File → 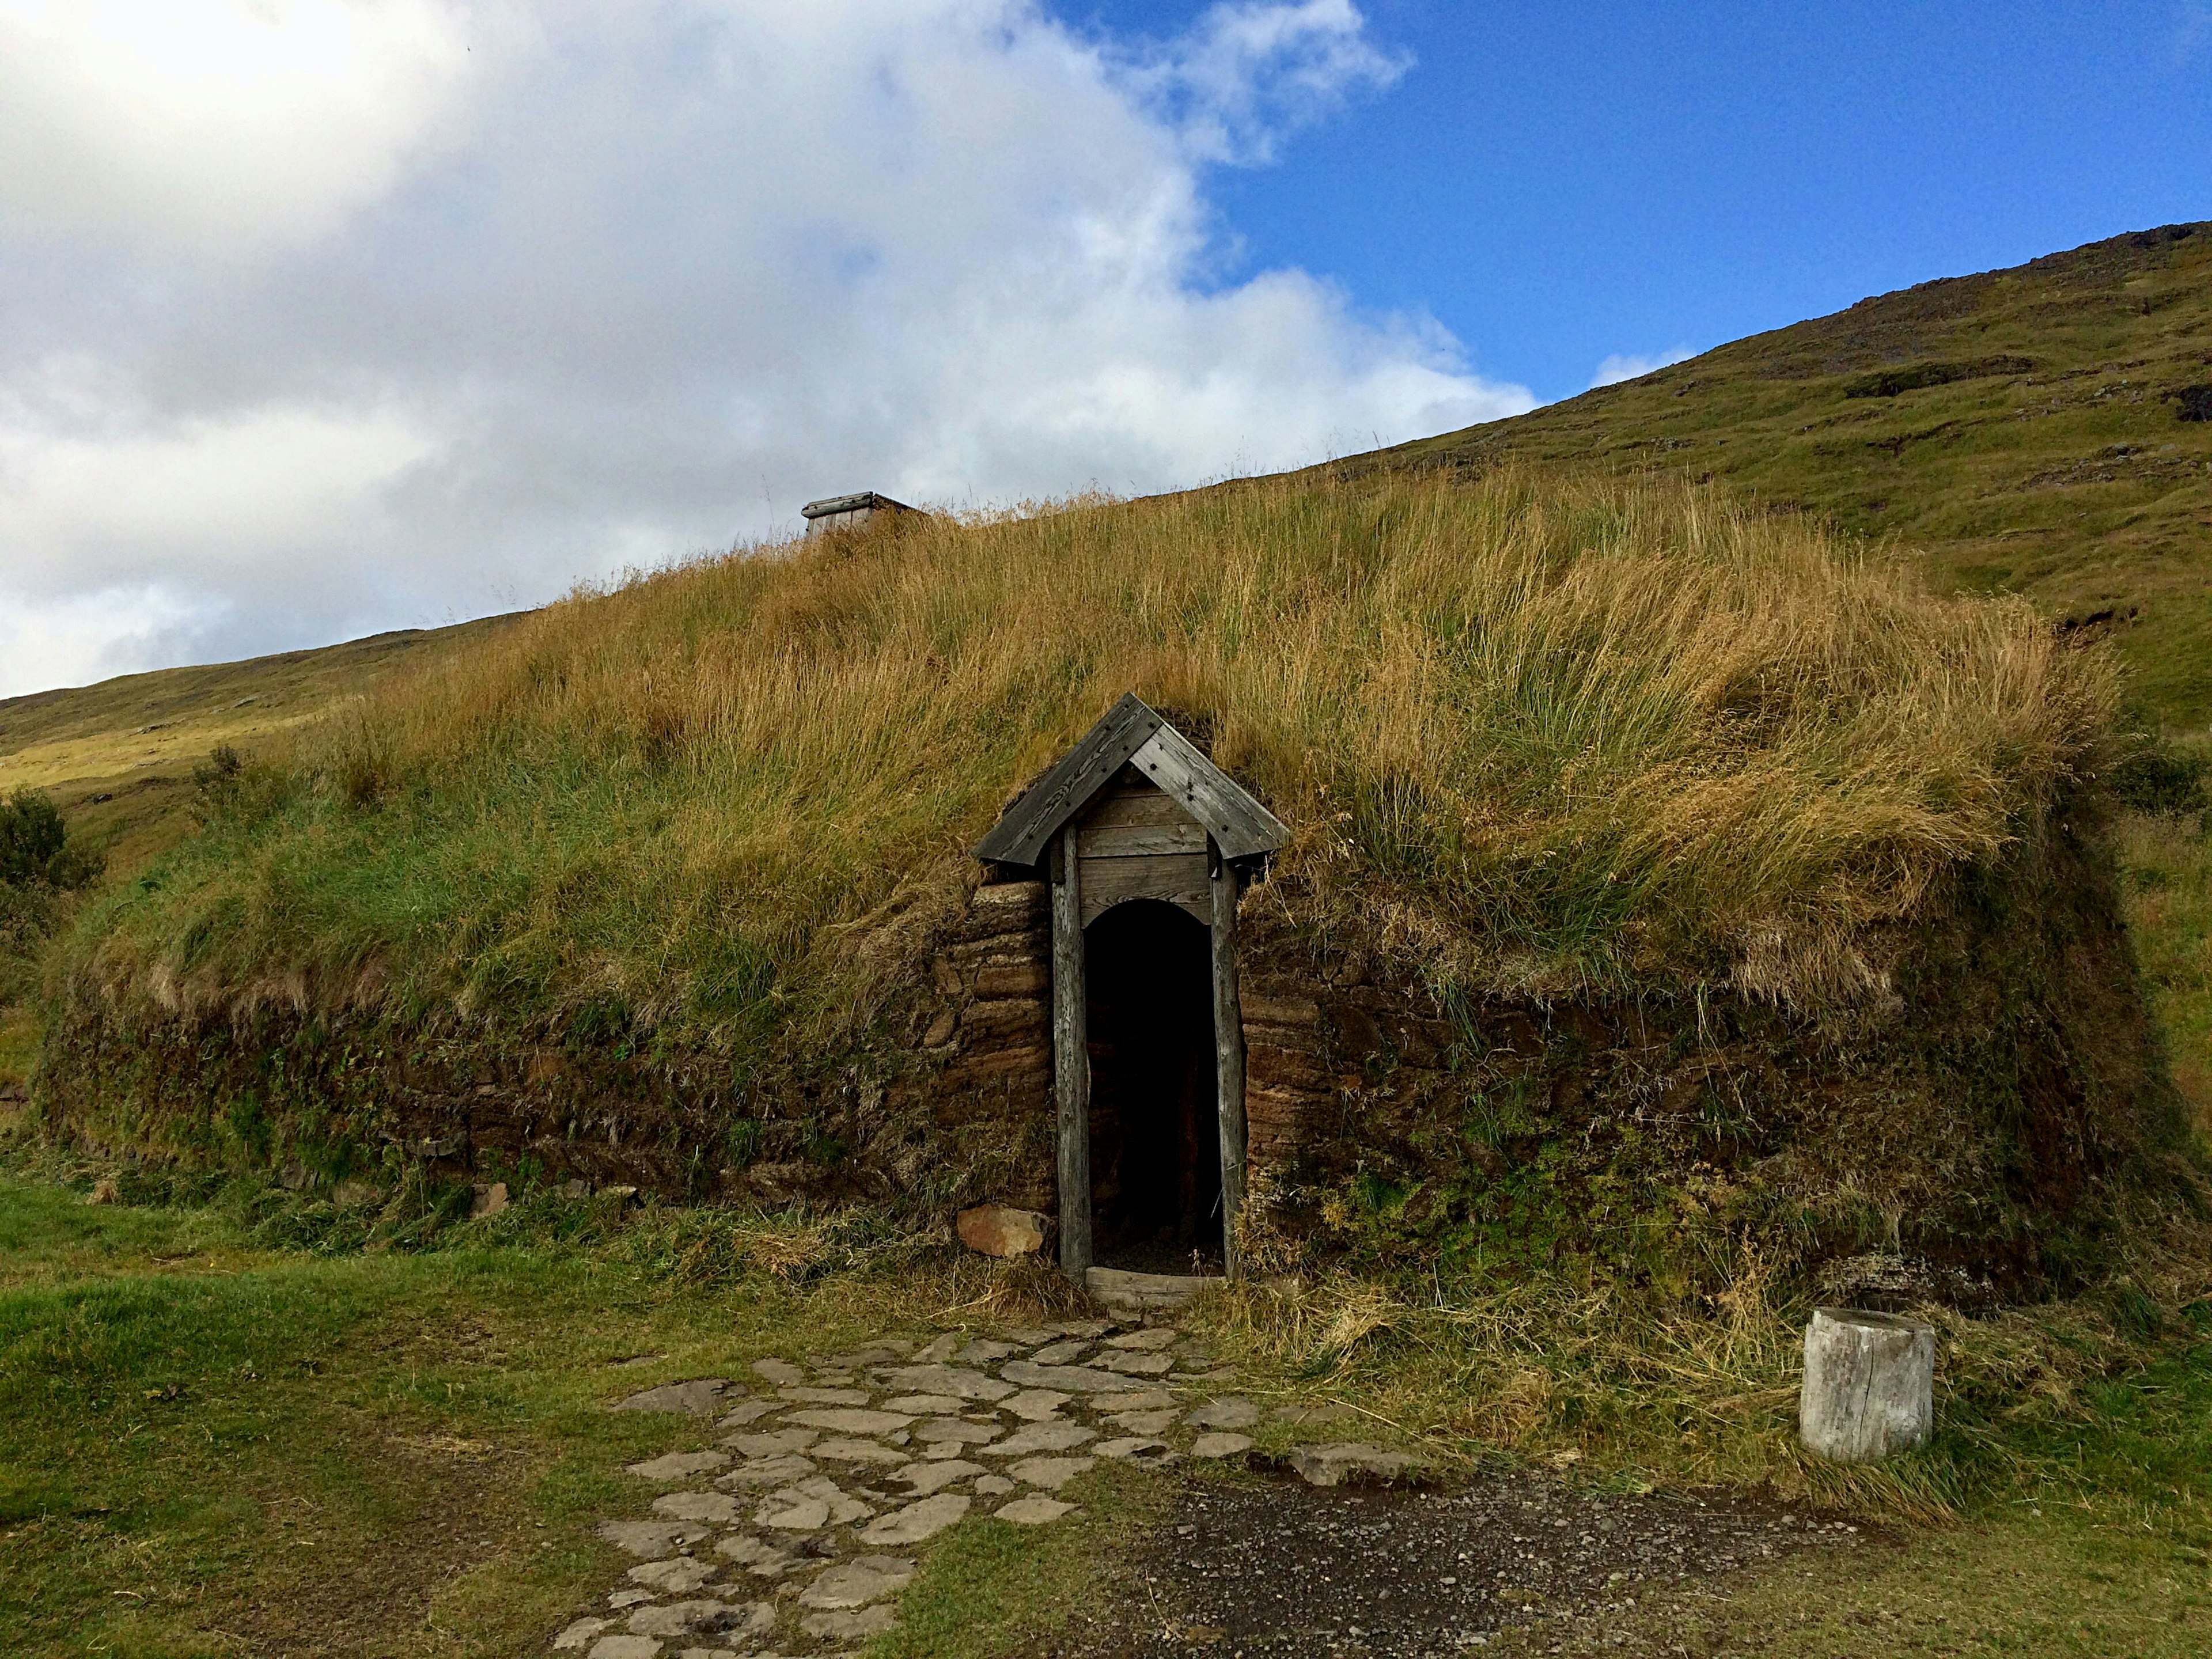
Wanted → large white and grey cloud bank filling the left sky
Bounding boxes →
[0,0,1533,692]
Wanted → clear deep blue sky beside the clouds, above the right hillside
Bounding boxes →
[1058,0,2212,400]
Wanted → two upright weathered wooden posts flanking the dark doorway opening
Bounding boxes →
[1051,821,1245,1283]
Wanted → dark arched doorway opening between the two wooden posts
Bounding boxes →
[1084,898,1221,1274]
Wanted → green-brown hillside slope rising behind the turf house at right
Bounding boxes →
[1362,221,2212,728]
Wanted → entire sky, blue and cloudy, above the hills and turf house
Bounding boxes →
[0,0,2212,695]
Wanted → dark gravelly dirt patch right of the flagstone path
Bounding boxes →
[1046,1475,1862,1659]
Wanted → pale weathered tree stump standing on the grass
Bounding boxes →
[1798,1307,1936,1462]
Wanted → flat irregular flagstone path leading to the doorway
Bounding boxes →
[553,1320,1336,1659]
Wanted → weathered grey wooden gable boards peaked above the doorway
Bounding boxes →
[975,692,1290,865]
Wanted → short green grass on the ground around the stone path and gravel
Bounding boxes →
[0,1146,2212,1659]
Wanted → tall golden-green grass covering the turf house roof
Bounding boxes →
[97,476,2115,1039]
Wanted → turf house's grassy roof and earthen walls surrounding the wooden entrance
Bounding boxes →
[40,471,2179,1283]
